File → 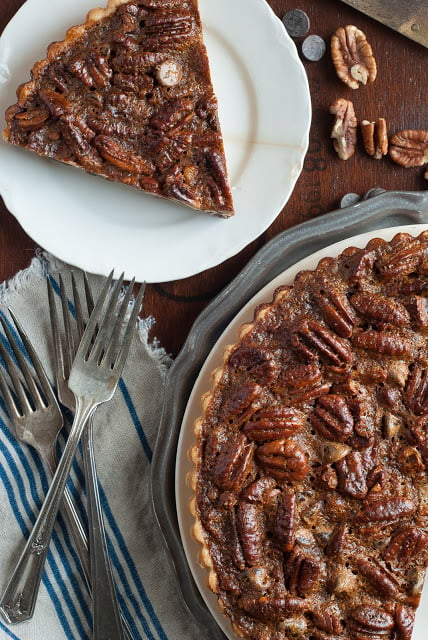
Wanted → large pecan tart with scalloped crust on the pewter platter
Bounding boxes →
[190,232,428,640]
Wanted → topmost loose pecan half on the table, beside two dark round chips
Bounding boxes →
[331,25,377,89]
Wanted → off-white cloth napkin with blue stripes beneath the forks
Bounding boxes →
[0,253,201,640]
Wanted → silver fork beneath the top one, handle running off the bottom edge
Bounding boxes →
[47,271,137,640]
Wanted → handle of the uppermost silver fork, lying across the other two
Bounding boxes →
[0,401,97,624]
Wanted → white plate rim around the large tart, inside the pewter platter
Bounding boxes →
[176,224,428,640]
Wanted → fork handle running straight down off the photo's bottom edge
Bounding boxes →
[82,416,124,640]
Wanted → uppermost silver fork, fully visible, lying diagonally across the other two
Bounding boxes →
[0,273,143,624]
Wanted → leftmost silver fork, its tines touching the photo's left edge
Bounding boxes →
[0,309,89,580]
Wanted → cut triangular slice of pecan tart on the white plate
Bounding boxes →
[3,0,233,217]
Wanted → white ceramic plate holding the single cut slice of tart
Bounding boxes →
[0,0,311,282]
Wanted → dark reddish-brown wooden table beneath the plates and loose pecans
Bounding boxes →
[0,0,428,356]
